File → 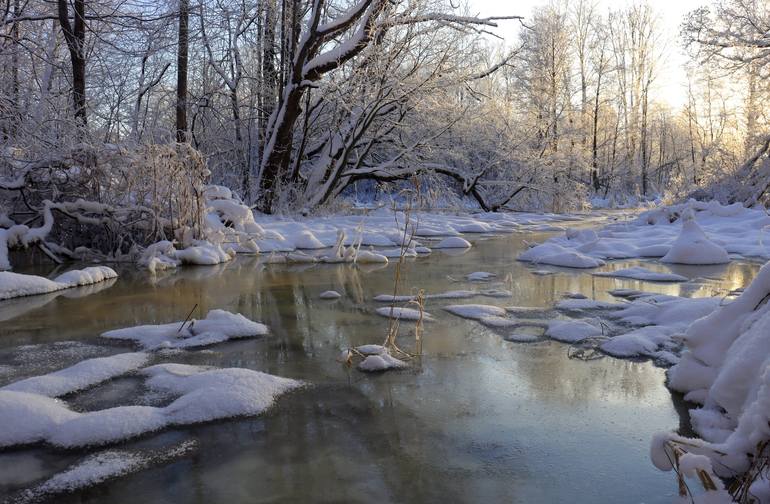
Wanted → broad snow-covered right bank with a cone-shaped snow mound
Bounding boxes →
[518,200,770,268]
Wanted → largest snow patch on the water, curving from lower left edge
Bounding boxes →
[0,364,303,448]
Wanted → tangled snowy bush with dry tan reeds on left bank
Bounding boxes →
[0,144,209,269]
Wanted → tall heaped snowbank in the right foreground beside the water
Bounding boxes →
[651,264,770,502]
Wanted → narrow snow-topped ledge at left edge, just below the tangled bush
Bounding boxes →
[0,266,118,300]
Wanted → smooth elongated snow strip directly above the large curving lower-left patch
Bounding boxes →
[0,353,150,397]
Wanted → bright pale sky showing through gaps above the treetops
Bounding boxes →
[467,0,710,108]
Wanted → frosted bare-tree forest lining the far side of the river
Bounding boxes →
[0,0,770,258]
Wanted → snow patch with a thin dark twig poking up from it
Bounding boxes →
[101,310,268,350]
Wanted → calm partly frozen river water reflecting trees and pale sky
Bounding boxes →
[0,230,758,503]
